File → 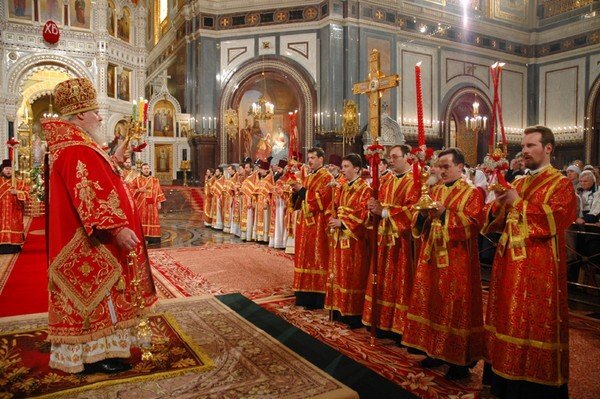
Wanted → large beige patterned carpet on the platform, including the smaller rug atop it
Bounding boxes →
[0,297,358,399]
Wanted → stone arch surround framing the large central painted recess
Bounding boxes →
[218,57,316,162]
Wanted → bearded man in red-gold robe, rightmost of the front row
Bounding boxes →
[484,126,577,399]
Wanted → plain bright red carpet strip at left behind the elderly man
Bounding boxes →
[0,216,48,317]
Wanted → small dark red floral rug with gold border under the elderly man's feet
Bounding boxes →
[0,314,213,398]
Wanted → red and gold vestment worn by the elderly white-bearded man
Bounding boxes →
[42,120,157,344]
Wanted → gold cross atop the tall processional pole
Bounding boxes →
[352,49,400,144]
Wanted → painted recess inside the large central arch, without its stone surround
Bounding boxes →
[227,71,303,162]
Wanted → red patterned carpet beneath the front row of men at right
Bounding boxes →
[257,298,600,399]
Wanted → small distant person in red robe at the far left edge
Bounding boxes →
[0,159,29,254]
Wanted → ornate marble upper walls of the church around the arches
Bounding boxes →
[0,0,600,170]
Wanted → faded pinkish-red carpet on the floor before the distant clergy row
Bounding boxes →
[149,244,294,299]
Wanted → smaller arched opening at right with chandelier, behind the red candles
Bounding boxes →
[442,87,492,166]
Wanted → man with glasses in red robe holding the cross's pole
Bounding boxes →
[362,145,418,340]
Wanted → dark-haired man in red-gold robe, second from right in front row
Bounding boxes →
[402,148,484,380]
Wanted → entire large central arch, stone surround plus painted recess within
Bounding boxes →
[219,57,316,162]
